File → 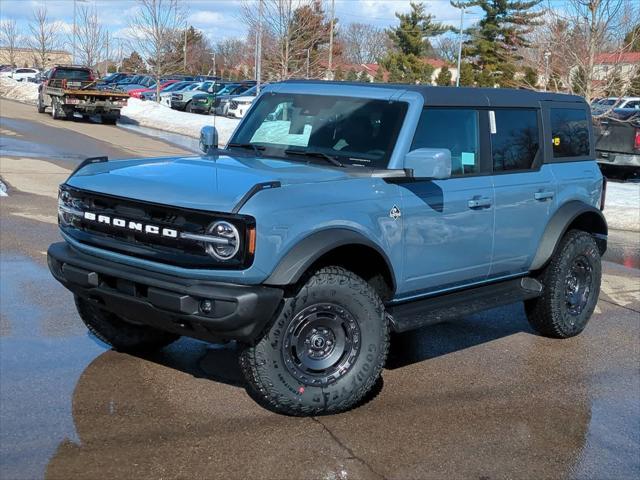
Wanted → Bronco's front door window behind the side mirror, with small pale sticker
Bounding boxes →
[411,108,480,176]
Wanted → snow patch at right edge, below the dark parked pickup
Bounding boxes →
[604,182,640,232]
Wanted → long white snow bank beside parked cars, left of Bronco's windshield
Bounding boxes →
[121,98,239,145]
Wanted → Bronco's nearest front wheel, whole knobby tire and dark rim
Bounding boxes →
[240,267,389,416]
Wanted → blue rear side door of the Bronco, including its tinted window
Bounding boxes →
[489,108,557,278]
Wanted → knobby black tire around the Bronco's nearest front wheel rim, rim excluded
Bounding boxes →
[240,267,389,416]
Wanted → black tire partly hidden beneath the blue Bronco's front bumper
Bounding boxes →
[75,296,180,352]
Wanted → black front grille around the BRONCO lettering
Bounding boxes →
[60,185,255,269]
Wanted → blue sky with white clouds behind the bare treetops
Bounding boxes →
[0,0,479,46]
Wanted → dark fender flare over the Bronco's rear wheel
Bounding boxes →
[529,201,608,270]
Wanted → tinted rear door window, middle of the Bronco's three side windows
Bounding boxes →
[491,109,540,172]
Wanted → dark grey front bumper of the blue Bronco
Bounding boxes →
[47,242,283,342]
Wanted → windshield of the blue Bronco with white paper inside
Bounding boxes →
[229,93,407,168]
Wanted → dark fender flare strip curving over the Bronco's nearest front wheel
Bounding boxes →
[263,228,396,291]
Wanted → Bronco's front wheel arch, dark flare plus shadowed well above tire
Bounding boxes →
[264,228,396,299]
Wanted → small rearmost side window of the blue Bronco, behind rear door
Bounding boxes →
[551,108,589,158]
